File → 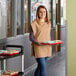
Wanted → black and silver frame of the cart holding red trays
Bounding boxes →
[0,45,24,76]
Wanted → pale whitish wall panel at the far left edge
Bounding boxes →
[0,0,7,39]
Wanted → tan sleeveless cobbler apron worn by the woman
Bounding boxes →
[31,20,52,58]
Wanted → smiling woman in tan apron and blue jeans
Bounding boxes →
[30,5,52,76]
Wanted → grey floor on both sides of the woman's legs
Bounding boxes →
[25,52,65,76]
